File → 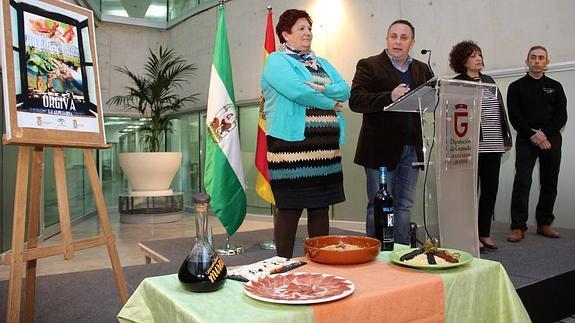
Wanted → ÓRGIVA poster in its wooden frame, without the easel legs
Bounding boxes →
[0,0,106,147]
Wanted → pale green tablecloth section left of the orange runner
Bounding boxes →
[118,274,313,323]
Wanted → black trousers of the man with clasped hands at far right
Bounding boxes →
[511,134,562,229]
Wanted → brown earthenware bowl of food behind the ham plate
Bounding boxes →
[303,236,381,265]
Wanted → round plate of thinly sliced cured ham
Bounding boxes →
[244,272,355,304]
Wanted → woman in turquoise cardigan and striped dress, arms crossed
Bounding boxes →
[262,9,349,258]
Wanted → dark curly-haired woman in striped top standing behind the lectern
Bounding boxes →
[449,40,512,251]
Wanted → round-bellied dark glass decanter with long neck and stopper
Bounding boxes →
[178,193,227,292]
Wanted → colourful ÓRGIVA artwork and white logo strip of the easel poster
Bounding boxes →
[17,5,99,132]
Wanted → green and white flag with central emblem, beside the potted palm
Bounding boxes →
[204,5,246,236]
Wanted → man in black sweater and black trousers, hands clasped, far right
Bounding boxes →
[507,46,567,242]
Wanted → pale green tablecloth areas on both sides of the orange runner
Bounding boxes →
[118,252,530,323]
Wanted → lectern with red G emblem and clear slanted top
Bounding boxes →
[384,78,497,257]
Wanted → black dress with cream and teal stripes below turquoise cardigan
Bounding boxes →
[267,108,345,209]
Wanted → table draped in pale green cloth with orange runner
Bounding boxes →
[118,252,530,322]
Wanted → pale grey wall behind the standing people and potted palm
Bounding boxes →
[97,0,575,228]
